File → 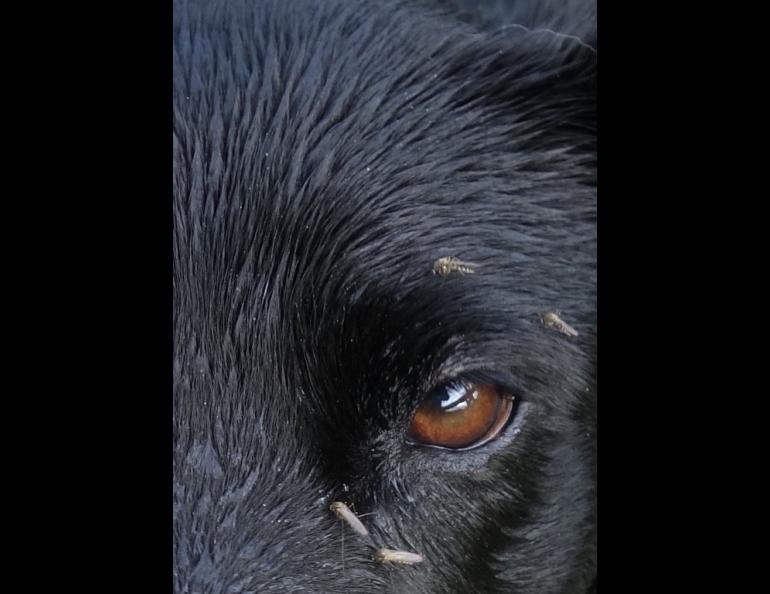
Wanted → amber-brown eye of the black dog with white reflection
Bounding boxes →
[408,381,514,450]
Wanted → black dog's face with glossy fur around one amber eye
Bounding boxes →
[174,0,596,594]
